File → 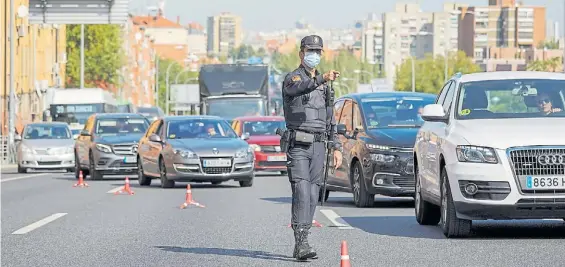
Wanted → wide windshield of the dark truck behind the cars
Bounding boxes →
[206,98,266,120]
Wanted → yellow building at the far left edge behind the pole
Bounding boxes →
[0,0,67,135]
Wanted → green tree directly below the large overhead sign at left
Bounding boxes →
[66,25,125,88]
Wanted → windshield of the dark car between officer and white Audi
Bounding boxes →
[361,97,435,129]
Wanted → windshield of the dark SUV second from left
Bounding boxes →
[96,118,149,135]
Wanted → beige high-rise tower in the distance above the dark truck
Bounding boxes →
[208,13,243,55]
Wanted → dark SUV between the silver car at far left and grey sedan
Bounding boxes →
[75,113,149,180]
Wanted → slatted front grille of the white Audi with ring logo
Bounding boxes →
[508,148,565,194]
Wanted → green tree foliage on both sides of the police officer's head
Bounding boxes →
[272,45,384,96]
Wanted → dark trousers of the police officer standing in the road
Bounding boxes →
[287,142,326,228]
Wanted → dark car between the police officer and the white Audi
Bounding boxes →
[320,92,436,207]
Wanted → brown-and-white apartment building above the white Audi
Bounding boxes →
[458,0,546,60]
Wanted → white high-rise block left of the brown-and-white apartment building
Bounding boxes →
[383,3,452,83]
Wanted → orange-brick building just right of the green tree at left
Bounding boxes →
[118,16,157,106]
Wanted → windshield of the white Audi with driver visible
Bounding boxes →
[456,79,565,120]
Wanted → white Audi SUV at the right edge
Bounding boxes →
[414,71,565,237]
